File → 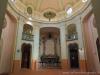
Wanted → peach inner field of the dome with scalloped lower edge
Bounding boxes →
[20,0,80,12]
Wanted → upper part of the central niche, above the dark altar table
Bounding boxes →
[40,27,60,56]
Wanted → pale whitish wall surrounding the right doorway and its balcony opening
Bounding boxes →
[65,15,85,60]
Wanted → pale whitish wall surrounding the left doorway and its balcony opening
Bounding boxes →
[15,16,34,60]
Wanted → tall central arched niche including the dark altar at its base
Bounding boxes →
[39,27,61,67]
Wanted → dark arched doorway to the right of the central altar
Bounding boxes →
[68,43,79,68]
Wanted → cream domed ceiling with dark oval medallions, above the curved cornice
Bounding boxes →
[10,0,88,21]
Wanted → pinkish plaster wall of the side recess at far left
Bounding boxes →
[0,13,17,73]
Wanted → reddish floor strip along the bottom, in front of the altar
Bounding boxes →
[10,69,100,75]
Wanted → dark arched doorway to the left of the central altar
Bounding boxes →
[21,43,32,68]
